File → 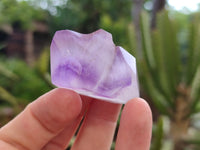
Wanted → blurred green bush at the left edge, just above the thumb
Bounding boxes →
[0,57,51,103]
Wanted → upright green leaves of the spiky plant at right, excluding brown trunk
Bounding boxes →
[129,11,200,117]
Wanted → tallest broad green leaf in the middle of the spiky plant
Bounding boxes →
[157,11,181,95]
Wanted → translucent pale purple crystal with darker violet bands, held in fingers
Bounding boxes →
[51,29,139,103]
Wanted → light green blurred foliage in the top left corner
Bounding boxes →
[0,0,46,29]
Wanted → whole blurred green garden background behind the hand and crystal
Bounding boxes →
[0,0,200,150]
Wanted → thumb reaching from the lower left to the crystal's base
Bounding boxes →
[0,88,82,150]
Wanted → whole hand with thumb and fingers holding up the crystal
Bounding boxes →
[0,88,152,150]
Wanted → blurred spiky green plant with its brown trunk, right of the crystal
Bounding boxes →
[129,11,200,150]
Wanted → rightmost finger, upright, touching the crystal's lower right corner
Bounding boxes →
[116,98,152,150]
